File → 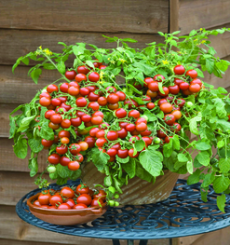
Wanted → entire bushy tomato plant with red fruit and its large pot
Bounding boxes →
[10,28,230,211]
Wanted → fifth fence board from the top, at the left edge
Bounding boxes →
[0,138,48,174]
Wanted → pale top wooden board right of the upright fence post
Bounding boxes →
[178,0,230,34]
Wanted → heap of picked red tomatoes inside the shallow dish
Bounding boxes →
[33,184,106,209]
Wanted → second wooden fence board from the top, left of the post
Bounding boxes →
[0,29,163,65]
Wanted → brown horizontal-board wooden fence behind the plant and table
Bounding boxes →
[0,0,230,245]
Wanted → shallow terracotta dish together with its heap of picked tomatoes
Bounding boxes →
[27,184,108,225]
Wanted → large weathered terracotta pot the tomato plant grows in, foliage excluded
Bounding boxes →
[81,162,179,205]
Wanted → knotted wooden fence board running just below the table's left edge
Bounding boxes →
[0,205,169,245]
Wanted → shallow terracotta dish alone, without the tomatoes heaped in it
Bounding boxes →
[27,193,108,225]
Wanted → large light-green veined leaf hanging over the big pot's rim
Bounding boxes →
[139,147,163,176]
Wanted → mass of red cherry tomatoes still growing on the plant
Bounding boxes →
[36,62,203,171]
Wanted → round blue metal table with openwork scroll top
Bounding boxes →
[16,180,230,245]
